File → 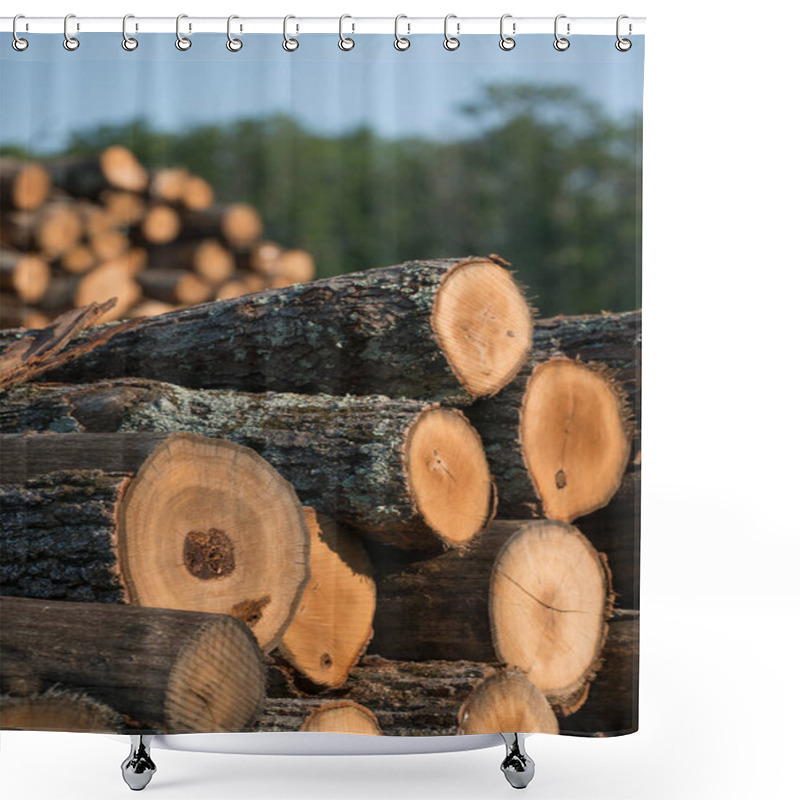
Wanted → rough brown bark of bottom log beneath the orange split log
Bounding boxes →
[255,656,493,736]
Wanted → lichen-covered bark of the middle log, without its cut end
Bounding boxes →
[0,380,482,549]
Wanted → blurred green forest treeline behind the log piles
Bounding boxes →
[0,84,641,315]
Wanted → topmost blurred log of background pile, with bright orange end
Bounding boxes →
[48,145,149,199]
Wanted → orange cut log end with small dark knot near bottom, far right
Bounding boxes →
[520,358,631,522]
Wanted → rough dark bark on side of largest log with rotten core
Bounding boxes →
[0,470,130,603]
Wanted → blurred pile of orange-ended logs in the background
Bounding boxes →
[0,146,314,328]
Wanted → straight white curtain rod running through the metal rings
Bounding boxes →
[0,15,645,36]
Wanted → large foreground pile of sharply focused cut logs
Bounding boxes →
[0,244,641,735]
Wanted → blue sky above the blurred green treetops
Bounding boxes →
[0,33,644,152]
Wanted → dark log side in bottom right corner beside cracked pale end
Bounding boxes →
[561,610,639,736]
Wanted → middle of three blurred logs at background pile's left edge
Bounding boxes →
[0,201,83,258]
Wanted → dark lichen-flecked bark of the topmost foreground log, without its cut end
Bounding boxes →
[31,259,520,400]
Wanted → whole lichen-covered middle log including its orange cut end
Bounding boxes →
[0,379,493,550]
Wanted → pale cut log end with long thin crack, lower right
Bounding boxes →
[489,520,613,713]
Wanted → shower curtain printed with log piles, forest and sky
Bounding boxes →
[0,21,644,736]
